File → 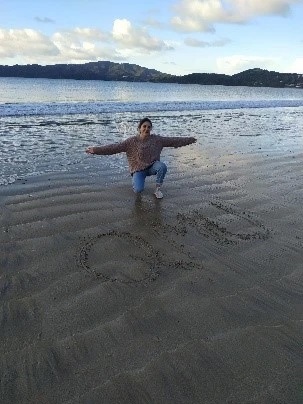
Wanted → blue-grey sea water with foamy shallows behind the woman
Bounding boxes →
[0,78,303,186]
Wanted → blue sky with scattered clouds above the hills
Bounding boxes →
[0,0,303,75]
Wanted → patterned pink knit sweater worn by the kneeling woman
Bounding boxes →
[93,135,196,174]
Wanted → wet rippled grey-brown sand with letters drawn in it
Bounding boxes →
[0,150,303,404]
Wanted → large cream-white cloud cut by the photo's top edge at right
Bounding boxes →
[171,0,302,32]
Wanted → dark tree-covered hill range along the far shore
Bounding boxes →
[0,61,303,88]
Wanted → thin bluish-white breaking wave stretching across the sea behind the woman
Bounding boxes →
[0,99,303,116]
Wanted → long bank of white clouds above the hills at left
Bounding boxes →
[0,20,172,64]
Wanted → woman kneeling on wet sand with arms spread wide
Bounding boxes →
[86,118,197,199]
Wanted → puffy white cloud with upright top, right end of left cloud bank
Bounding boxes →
[112,19,175,53]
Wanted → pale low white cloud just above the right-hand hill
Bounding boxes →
[217,55,277,74]
